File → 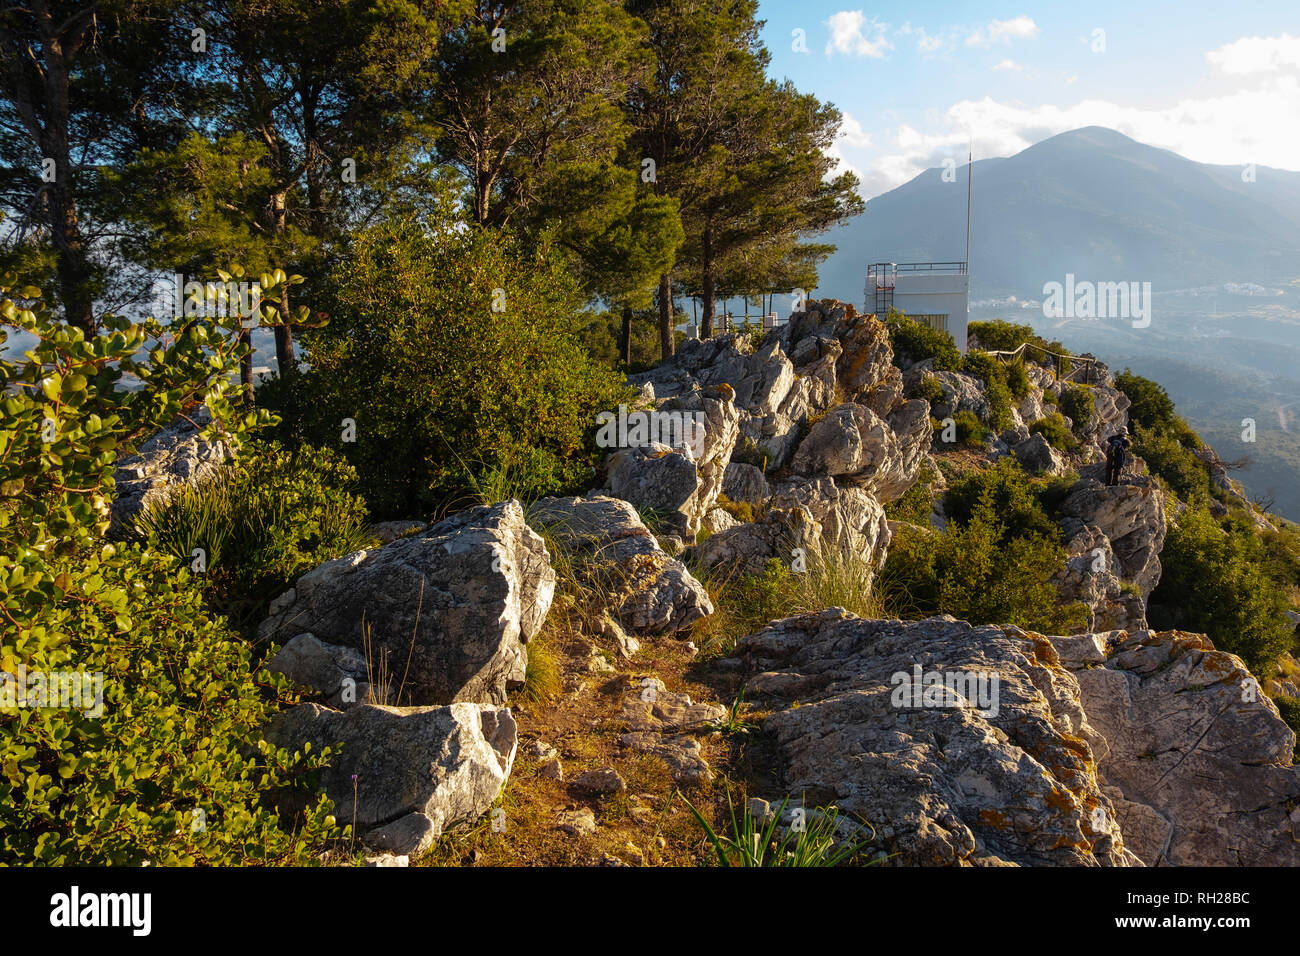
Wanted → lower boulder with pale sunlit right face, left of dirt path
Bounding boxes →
[265,704,517,855]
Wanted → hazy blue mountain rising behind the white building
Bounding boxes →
[816,126,1300,303]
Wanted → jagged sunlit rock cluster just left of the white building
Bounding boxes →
[624,299,932,587]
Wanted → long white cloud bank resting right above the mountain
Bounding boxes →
[854,75,1300,198]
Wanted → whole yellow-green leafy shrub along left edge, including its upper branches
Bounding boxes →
[0,277,333,866]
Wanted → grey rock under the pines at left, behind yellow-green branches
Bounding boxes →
[111,406,231,535]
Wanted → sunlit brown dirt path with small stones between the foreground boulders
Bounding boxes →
[416,624,779,866]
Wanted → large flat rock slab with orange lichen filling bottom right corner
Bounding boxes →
[732,609,1300,866]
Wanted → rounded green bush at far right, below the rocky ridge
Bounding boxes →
[1148,505,1294,675]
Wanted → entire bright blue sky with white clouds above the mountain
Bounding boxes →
[759,0,1300,198]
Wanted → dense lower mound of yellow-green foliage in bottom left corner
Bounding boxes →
[0,544,332,866]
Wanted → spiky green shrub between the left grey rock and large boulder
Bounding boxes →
[135,442,372,624]
